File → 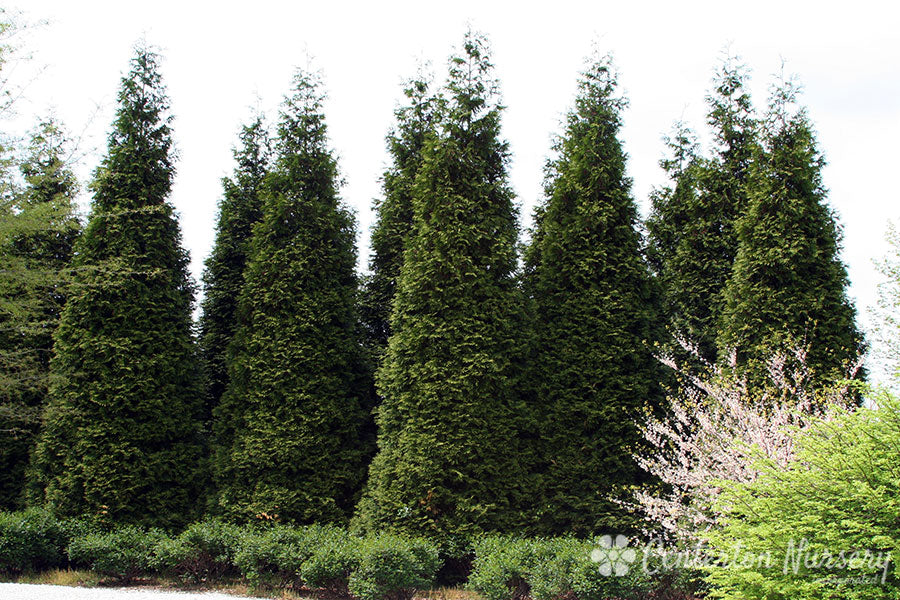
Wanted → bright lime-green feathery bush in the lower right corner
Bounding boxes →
[708,395,900,600]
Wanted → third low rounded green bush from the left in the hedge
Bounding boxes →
[154,520,245,582]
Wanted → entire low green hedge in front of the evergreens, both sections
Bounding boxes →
[12,509,716,600]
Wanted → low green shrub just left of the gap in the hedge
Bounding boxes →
[347,534,440,600]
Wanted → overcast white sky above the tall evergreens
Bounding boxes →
[12,0,900,340]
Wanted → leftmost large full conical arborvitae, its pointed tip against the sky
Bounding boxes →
[34,47,205,526]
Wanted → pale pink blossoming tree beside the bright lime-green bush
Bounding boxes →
[631,338,859,544]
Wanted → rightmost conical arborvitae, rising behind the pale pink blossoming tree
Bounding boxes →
[718,82,862,390]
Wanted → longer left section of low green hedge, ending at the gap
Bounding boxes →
[0,509,441,600]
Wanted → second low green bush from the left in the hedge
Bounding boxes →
[68,526,167,582]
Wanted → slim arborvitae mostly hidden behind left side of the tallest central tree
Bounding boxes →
[361,74,437,360]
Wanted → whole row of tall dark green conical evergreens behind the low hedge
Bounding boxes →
[0,34,861,548]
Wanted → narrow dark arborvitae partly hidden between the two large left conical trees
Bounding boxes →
[200,116,269,420]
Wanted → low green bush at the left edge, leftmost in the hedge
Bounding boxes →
[0,508,89,574]
